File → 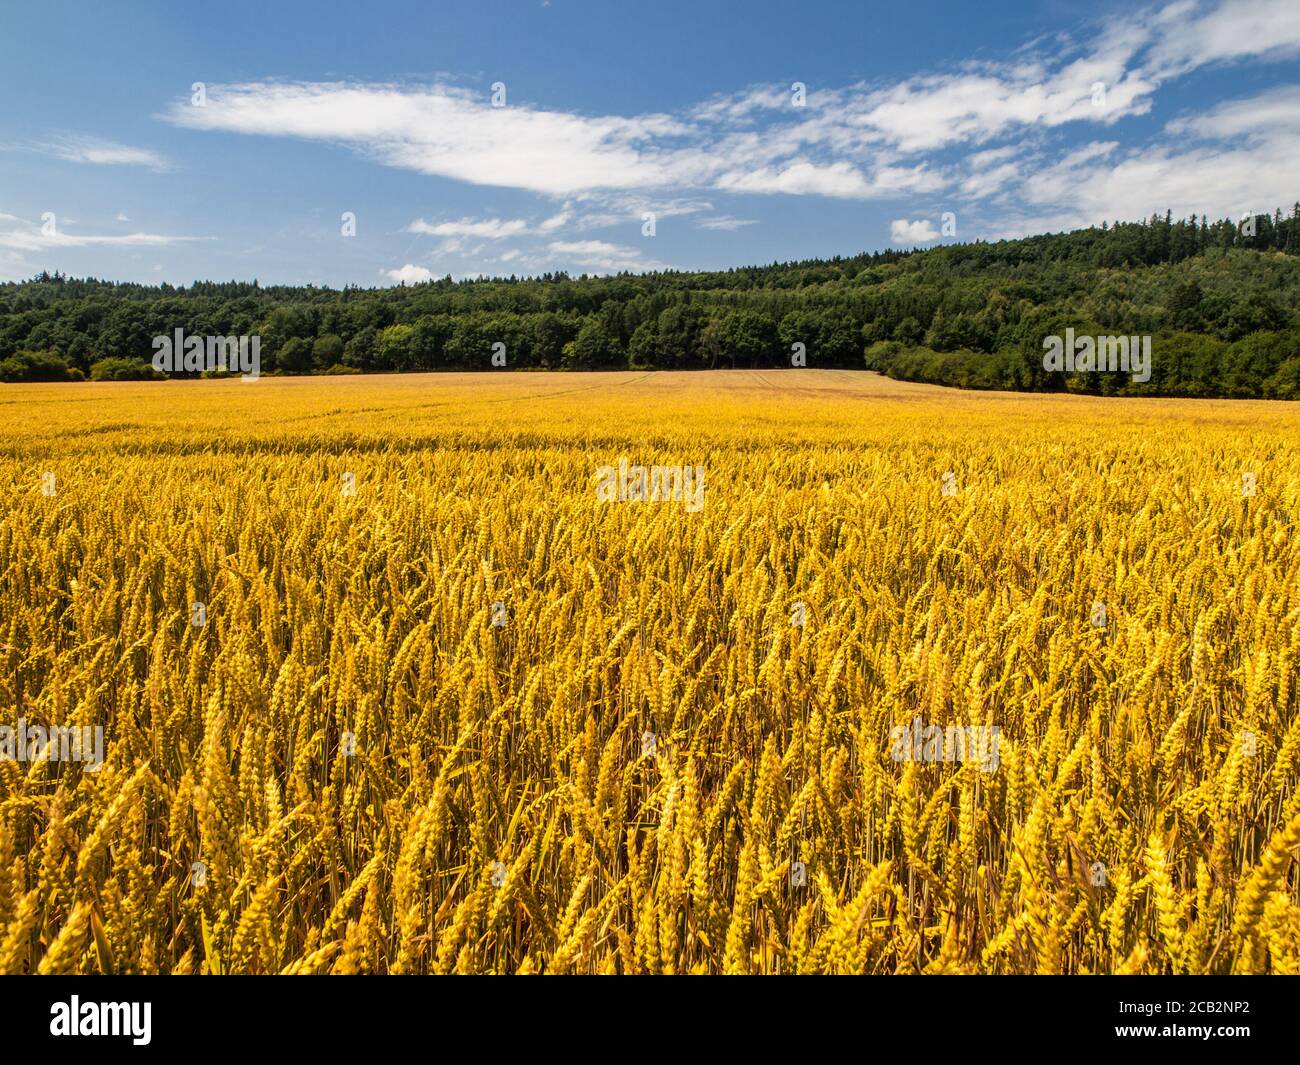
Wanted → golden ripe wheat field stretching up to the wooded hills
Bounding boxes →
[0,369,1300,974]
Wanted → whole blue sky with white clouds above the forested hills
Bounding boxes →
[0,0,1300,286]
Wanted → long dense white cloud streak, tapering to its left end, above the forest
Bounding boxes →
[165,82,972,198]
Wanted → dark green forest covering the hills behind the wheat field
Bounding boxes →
[0,203,1300,399]
